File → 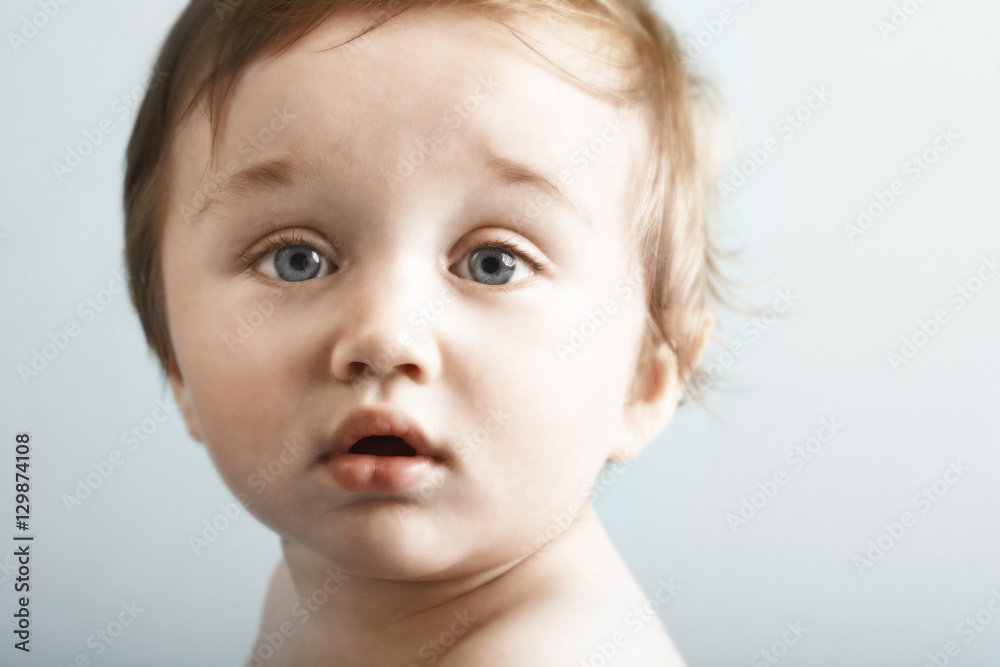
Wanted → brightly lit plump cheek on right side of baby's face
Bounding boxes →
[446,280,639,486]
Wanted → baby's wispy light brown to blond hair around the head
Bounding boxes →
[124,0,721,391]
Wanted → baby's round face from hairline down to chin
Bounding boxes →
[162,5,664,578]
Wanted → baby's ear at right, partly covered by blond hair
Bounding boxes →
[608,308,715,461]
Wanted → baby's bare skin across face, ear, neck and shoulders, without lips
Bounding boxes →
[163,9,704,667]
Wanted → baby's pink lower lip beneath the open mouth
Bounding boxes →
[325,454,441,493]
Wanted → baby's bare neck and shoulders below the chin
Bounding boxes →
[248,507,684,667]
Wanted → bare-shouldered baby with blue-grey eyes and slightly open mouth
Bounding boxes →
[125,0,715,667]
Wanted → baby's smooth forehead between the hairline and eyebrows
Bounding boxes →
[165,9,645,239]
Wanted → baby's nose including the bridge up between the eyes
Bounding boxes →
[332,250,439,382]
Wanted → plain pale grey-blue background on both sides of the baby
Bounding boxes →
[0,0,1000,667]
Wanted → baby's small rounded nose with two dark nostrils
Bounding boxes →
[331,265,441,385]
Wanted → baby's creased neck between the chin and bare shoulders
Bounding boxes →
[282,502,614,665]
